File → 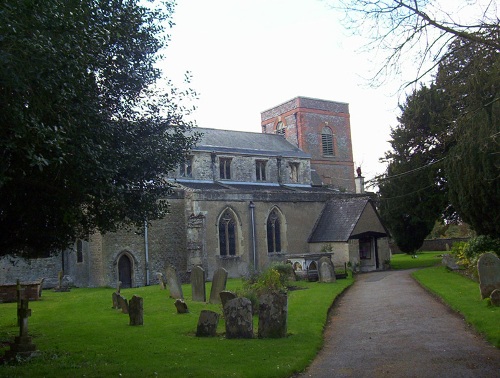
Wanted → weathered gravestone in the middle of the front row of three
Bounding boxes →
[224,298,253,339]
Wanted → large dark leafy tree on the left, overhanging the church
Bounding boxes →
[0,0,196,256]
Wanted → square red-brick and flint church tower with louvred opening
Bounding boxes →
[261,97,355,192]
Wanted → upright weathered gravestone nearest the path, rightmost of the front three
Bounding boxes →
[258,293,288,339]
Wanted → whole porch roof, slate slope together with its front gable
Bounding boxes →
[309,197,388,243]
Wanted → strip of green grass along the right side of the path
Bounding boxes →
[412,266,500,348]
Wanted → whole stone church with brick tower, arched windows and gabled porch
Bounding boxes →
[0,97,390,287]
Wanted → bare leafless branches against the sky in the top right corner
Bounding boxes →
[332,0,500,85]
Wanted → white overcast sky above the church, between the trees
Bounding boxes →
[158,0,466,185]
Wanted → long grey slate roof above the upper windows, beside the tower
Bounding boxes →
[193,127,311,159]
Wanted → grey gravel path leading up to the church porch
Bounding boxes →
[299,271,500,378]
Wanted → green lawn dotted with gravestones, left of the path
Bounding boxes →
[0,278,354,378]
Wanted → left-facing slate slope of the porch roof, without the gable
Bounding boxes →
[308,197,376,243]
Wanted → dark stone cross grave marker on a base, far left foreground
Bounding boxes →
[5,290,36,360]
